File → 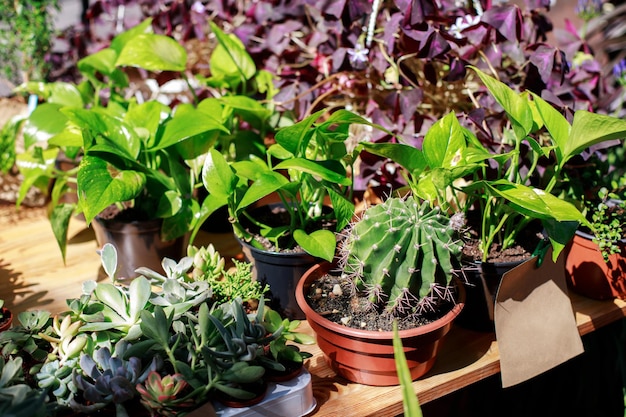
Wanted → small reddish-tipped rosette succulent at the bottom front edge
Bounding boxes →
[136,371,195,417]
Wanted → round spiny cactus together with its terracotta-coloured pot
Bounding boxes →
[296,196,465,385]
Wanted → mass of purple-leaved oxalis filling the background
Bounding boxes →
[45,0,623,194]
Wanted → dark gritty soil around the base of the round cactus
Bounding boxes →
[307,273,457,331]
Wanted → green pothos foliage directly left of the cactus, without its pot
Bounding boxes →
[202,110,386,261]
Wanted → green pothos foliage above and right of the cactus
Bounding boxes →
[363,68,626,261]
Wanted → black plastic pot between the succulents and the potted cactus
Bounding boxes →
[239,240,317,320]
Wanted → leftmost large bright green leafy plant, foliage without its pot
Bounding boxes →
[13,20,227,273]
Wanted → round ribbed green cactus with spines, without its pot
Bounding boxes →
[338,196,464,315]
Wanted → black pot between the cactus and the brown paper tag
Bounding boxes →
[455,260,525,332]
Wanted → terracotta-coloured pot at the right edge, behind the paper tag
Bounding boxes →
[565,231,626,300]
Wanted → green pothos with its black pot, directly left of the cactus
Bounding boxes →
[200,110,386,318]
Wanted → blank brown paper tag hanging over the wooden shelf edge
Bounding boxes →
[495,247,584,388]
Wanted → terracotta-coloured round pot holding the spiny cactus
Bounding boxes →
[296,263,465,386]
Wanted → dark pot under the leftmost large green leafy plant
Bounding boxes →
[91,217,189,279]
